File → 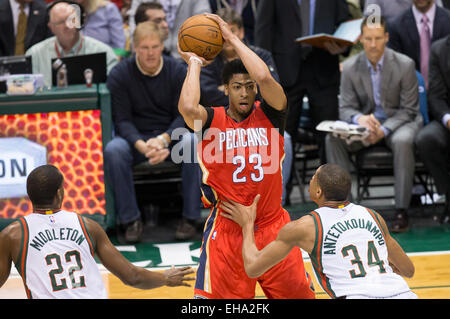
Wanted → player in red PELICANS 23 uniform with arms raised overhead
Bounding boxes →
[178,14,314,299]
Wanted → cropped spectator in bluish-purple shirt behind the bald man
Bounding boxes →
[75,0,125,49]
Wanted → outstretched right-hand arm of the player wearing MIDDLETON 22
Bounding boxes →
[84,218,194,289]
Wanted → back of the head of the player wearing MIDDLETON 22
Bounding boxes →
[27,165,64,206]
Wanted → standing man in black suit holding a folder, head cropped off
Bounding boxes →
[255,0,351,162]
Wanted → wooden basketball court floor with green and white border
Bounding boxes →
[0,178,450,299]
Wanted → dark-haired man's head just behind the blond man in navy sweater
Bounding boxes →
[134,2,170,55]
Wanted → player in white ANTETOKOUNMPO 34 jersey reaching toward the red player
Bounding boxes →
[222,164,417,299]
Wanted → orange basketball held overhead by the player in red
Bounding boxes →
[178,14,223,60]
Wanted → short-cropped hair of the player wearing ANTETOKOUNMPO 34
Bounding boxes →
[316,164,352,201]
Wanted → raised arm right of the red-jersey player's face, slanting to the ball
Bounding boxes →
[205,13,287,111]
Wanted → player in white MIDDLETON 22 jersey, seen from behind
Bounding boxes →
[0,165,194,299]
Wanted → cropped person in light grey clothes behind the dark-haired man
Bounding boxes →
[129,0,211,58]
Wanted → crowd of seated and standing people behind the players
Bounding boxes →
[0,0,450,242]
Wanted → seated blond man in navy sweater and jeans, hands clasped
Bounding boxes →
[104,21,201,242]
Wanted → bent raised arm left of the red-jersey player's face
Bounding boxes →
[178,45,208,131]
